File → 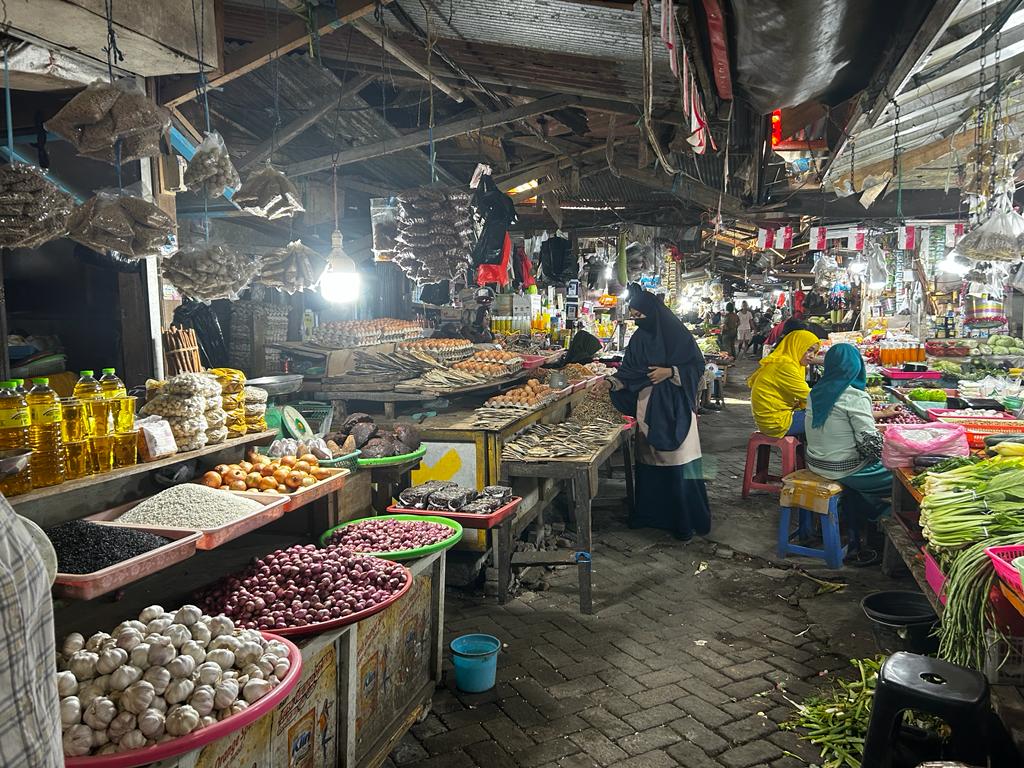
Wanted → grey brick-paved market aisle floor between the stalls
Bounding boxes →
[388,364,886,768]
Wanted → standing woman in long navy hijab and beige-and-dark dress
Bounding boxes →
[602,284,711,541]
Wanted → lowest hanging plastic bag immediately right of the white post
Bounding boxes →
[161,243,260,302]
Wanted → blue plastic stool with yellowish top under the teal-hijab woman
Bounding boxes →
[778,469,846,568]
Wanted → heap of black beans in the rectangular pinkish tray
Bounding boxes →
[46,520,171,573]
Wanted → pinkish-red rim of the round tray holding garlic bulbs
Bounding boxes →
[65,632,302,768]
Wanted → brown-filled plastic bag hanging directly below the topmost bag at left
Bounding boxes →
[68,191,175,258]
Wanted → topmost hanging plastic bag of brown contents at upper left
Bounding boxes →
[44,78,171,163]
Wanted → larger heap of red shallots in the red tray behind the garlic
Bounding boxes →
[197,544,407,629]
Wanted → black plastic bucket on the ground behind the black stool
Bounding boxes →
[860,590,939,655]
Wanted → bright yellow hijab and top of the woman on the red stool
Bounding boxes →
[746,331,821,437]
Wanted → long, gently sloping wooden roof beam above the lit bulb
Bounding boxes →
[285,94,580,177]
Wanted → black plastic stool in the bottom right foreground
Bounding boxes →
[861,651,989,768]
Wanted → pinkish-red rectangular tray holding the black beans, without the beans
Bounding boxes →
[53,520,203,600]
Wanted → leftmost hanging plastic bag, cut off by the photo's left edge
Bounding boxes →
[0,163,75,248]
